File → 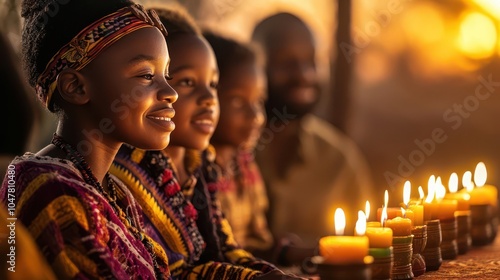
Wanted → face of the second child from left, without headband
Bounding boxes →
[168,34,219,150]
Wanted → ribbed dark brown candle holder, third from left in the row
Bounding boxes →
[391,235,414,279]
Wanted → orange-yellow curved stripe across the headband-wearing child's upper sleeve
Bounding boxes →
[28,195,89,239]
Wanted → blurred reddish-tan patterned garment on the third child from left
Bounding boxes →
[211,151,273,251]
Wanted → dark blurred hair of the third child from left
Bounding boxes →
[203,31,261,82]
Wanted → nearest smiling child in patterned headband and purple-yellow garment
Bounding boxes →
[0,0,177,279]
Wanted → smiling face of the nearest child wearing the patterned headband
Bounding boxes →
[80,28,177,149]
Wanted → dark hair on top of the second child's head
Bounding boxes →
[152,6,201,38]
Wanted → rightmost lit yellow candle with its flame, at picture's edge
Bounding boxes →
[469,162,498,206]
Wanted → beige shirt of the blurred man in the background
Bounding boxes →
[257,115,373,246]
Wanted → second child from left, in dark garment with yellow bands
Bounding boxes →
[112,6,304,279]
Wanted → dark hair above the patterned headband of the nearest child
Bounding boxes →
[21,0,132,89]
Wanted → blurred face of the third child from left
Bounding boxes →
[212,63,266,148]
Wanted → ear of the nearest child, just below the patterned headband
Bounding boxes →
[57,69,90,105]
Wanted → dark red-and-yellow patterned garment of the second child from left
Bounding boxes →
[110,145,276,279]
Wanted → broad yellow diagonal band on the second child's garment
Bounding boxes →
[109,164,188,257]
